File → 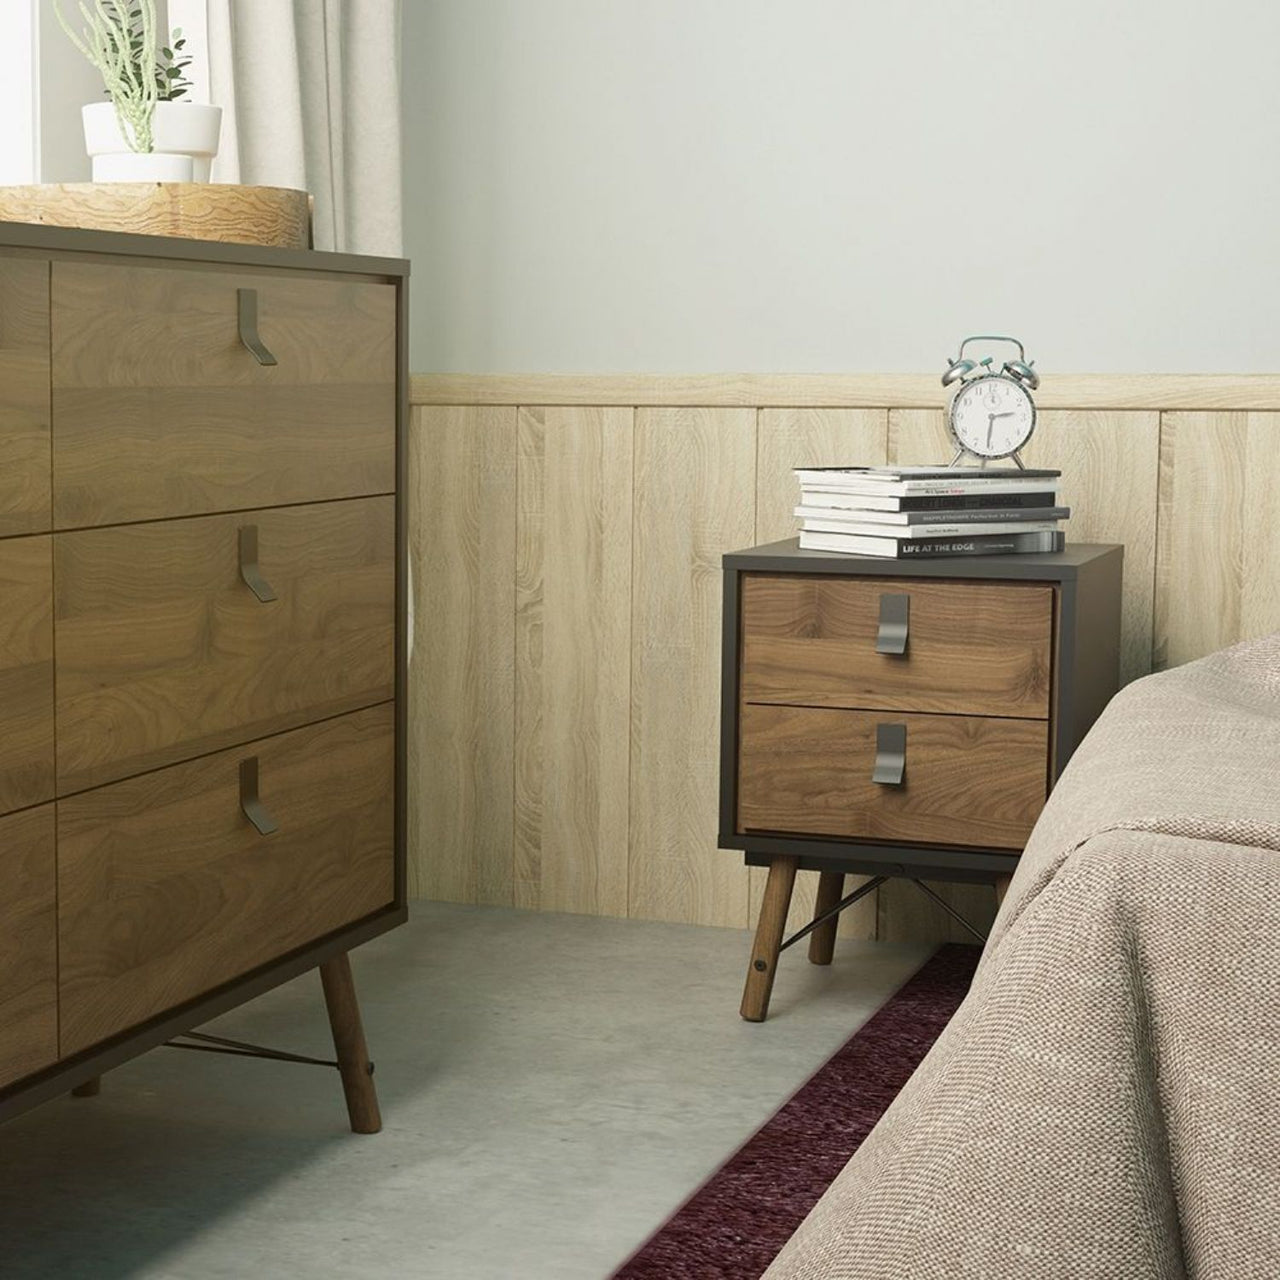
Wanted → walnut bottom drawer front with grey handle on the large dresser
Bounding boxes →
[58,704,396,1057]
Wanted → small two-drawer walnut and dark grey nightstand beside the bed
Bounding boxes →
[719,539,1124,1021]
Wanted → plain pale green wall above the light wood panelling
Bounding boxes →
[404,0,1280,371]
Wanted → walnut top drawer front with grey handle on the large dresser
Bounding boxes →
[52,262,397,529]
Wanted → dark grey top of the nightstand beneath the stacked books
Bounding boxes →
[724,538,1124,582]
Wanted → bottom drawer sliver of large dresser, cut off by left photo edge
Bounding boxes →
[0,804,58,1089]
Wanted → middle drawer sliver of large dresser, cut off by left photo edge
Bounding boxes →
[0,535,54,813]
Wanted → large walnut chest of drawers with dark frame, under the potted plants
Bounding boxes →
[0,225,408,1130]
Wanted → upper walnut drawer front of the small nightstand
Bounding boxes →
[741,573,1053,719]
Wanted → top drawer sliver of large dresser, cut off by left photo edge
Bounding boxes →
[0,257,50,538]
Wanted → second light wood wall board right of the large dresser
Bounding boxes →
[515,408,634,915]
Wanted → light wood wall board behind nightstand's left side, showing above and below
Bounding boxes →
[750,408,888,938]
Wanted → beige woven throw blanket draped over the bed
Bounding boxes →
[767,634,1280,1280]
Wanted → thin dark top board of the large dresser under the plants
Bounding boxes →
[0,221,408,275]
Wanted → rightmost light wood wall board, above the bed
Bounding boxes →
[1156,413,1280,667]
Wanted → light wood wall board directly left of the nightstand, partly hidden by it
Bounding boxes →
[631,408,755,928]
